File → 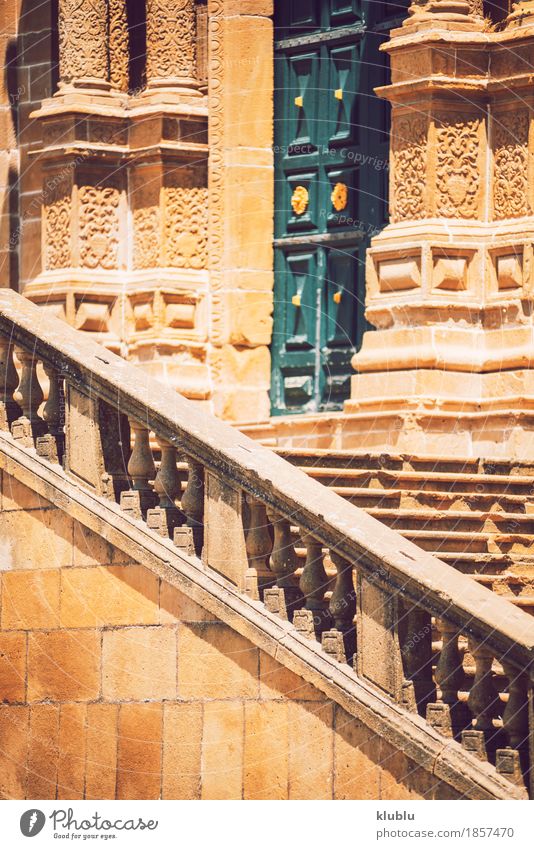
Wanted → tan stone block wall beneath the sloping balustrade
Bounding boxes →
[0,472,462,799]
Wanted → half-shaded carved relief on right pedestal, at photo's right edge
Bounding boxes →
[493,109,530,218]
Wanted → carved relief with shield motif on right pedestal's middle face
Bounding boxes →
[436,113,480,218]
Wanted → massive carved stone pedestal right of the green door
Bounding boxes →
[345,4,534,457]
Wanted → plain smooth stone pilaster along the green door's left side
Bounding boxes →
[208,0,274,421]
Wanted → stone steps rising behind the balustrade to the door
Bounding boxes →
[278,448,534,613]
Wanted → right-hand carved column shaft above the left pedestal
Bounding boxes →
[146,0,200,101]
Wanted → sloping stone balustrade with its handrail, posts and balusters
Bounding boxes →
[0,289,534,796]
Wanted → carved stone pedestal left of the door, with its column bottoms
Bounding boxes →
[24,0,210,401]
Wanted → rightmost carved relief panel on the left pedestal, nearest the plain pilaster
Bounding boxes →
[163,186,208,268]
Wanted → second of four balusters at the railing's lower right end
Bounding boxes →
[426,619,466,737]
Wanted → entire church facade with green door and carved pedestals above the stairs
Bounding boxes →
[1,0,534,458]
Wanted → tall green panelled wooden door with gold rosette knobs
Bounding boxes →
[271,0,406,415]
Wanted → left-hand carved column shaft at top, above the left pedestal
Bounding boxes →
[59,0,108,82]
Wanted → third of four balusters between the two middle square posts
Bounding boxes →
[293,531,331,639]
